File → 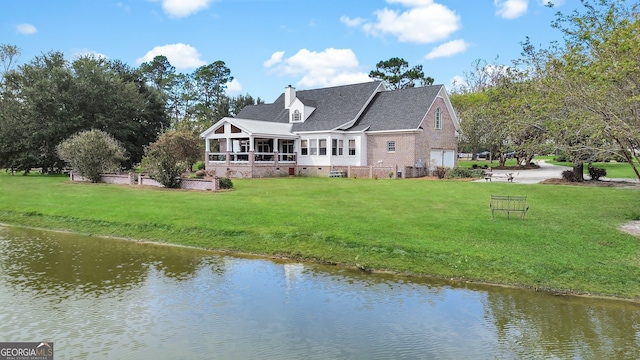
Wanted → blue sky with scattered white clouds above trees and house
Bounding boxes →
[0,0,581,102]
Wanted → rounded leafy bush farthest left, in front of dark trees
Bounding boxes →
[56,130,126,183]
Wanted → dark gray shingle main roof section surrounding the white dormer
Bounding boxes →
[236,81,381,132]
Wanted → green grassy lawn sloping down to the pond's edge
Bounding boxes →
[0,173,640,298]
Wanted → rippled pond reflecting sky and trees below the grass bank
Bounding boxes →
[0,227,640,359]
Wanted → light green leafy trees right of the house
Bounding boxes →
[451,0,640,181]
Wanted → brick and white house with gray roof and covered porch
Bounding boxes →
[200,81,459,178]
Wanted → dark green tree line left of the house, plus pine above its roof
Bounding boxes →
[0,44,433,180]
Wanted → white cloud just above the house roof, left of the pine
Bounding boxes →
[265,48,371,88]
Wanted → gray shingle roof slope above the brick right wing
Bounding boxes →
[350,85,443,131]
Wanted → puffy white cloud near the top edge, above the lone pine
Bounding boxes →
[341,0,461,44]
